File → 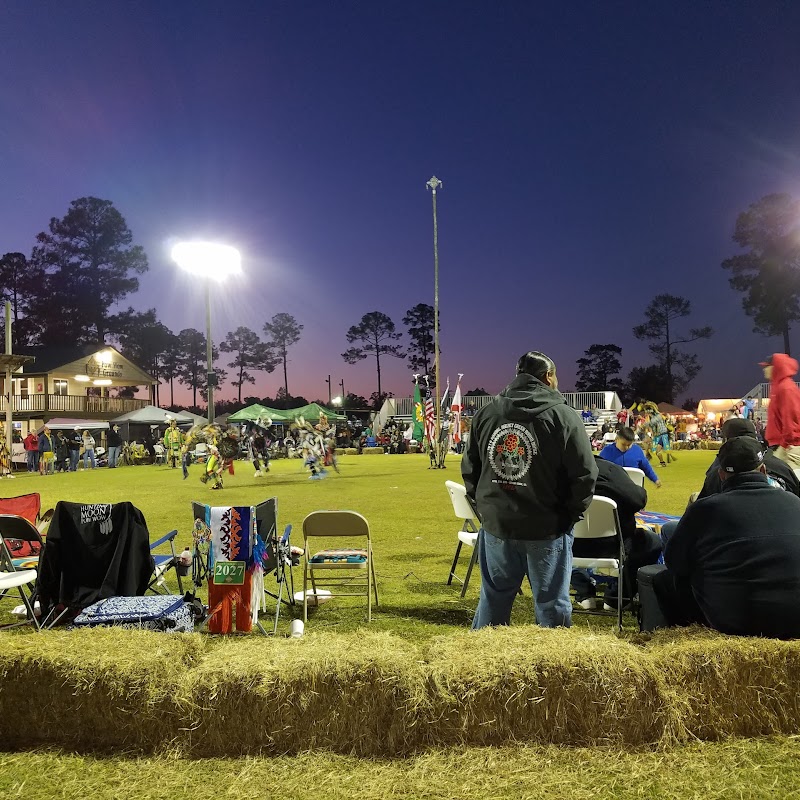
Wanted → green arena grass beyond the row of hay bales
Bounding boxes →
[0,451,714,638]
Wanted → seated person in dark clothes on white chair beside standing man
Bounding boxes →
[572,456,661,610]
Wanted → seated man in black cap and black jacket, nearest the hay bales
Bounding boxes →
[640,436,800,639]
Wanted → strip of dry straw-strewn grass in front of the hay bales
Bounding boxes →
[0,738,800,800]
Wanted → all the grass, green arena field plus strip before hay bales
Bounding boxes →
[6,452,800,800]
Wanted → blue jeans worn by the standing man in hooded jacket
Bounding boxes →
[472,529,573,630]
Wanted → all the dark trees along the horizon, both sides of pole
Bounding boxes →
[0,194,800,405]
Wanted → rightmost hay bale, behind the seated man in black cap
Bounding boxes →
[647,628,800,741]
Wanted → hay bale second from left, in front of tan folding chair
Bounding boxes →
[187,631,428,756]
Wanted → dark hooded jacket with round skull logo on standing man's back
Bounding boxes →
[461,375,597,540]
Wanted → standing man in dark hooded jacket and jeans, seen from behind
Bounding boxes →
[461,351,597,630]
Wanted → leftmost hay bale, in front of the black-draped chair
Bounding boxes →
[0,628,206,752]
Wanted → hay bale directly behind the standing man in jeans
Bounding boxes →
[426,626,682,746]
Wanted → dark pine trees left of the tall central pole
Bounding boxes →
[0,197,433,407]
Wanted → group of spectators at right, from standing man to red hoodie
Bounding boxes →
[462,351,800,638]
